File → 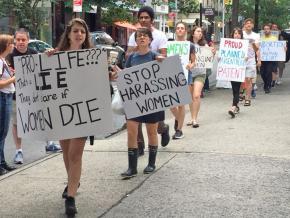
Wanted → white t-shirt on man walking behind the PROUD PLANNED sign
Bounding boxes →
[243,31,260,66]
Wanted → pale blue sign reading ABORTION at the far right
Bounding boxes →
[260,41,286,61]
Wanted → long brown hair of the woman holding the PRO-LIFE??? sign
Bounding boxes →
[57,18,93,51]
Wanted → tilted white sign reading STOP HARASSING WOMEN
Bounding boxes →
[117,56,191,119]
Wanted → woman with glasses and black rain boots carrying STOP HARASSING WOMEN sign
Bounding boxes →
[121,27,165,179]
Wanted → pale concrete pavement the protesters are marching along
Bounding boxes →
[0,64,290,218]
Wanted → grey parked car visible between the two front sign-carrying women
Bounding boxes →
[91,31,125,68]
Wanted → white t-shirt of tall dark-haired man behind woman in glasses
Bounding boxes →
[128,28,167,52]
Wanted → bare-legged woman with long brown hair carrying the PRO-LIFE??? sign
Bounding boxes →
[48,18,93,216]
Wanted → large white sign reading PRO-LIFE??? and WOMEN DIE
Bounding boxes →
[14,48,113,140]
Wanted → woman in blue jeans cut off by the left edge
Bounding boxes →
[0,34,15,176]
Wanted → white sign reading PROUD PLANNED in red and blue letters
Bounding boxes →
[216,38,249,82]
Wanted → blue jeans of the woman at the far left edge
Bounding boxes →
[0,92,13,164]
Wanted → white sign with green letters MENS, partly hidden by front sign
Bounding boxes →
[167,41,190,81]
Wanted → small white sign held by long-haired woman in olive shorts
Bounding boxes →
[195,46,214,69]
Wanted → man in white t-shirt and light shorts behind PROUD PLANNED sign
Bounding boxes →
[243,18,261,106]
